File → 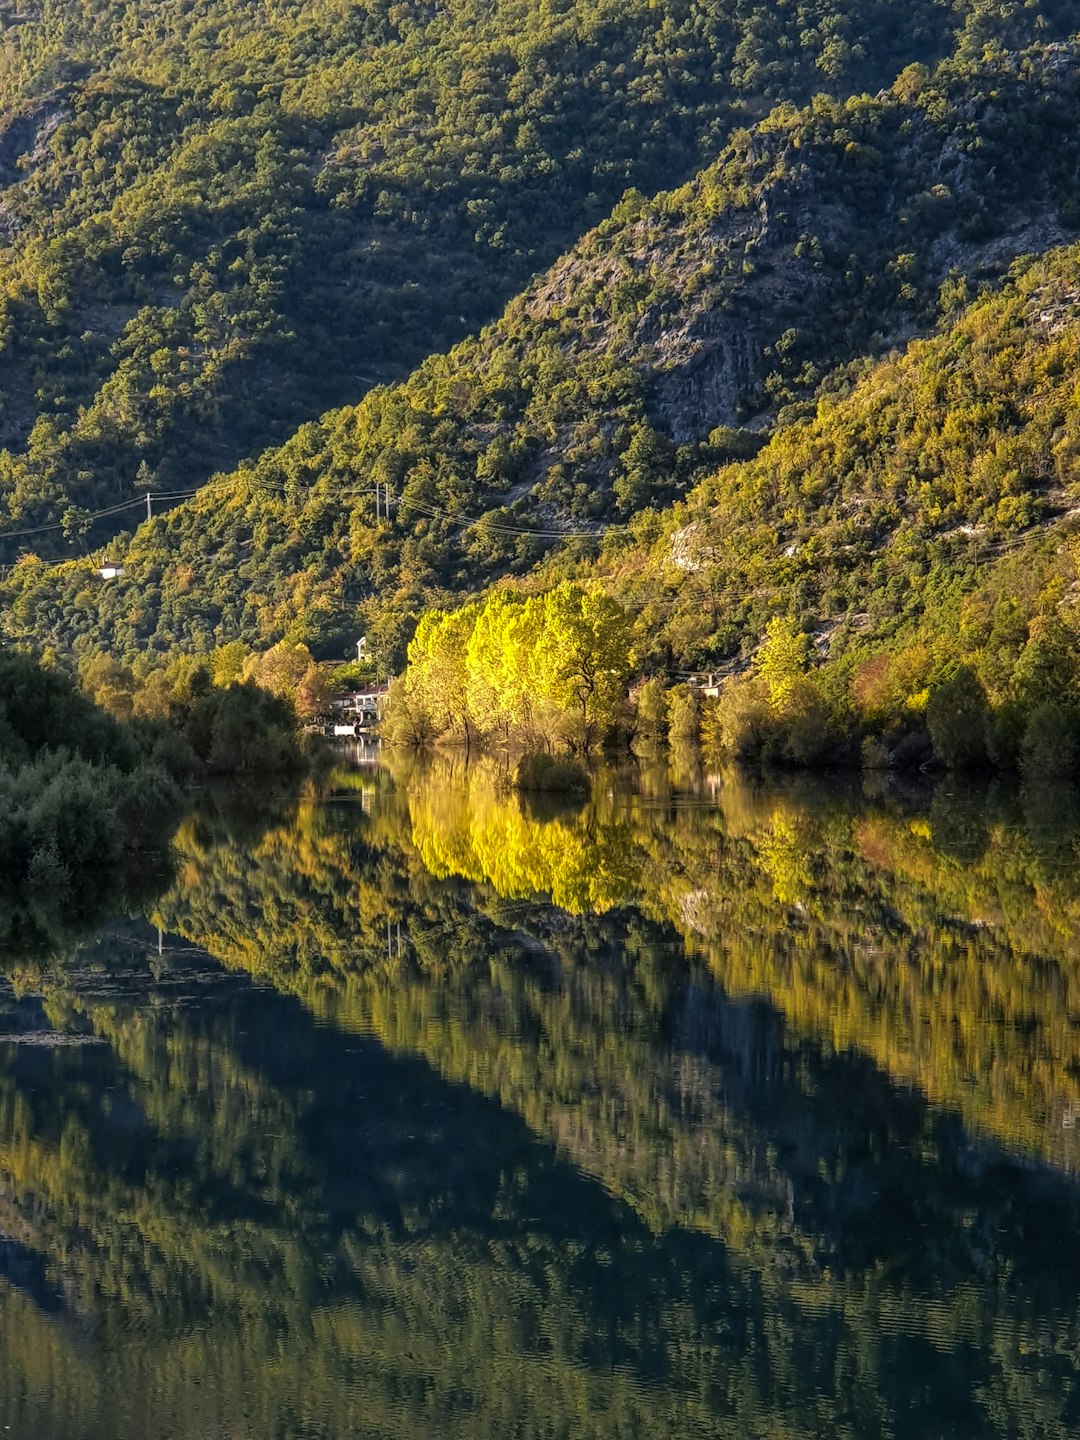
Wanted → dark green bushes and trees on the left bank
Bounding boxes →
[0,651,304,952]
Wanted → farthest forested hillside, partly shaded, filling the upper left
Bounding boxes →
[0,0,1002,549]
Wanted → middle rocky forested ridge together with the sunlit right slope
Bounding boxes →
[4,32,1080,667]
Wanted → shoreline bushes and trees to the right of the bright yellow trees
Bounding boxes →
[636,608,1080,780]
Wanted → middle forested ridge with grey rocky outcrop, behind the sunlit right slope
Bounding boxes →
[4,46,1080,662]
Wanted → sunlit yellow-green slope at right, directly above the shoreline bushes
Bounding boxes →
[600,236,1080,667]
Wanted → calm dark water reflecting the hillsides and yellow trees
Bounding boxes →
[0,762,1080,1440]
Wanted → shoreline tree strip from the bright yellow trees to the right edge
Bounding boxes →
[383,561,1080,779]
